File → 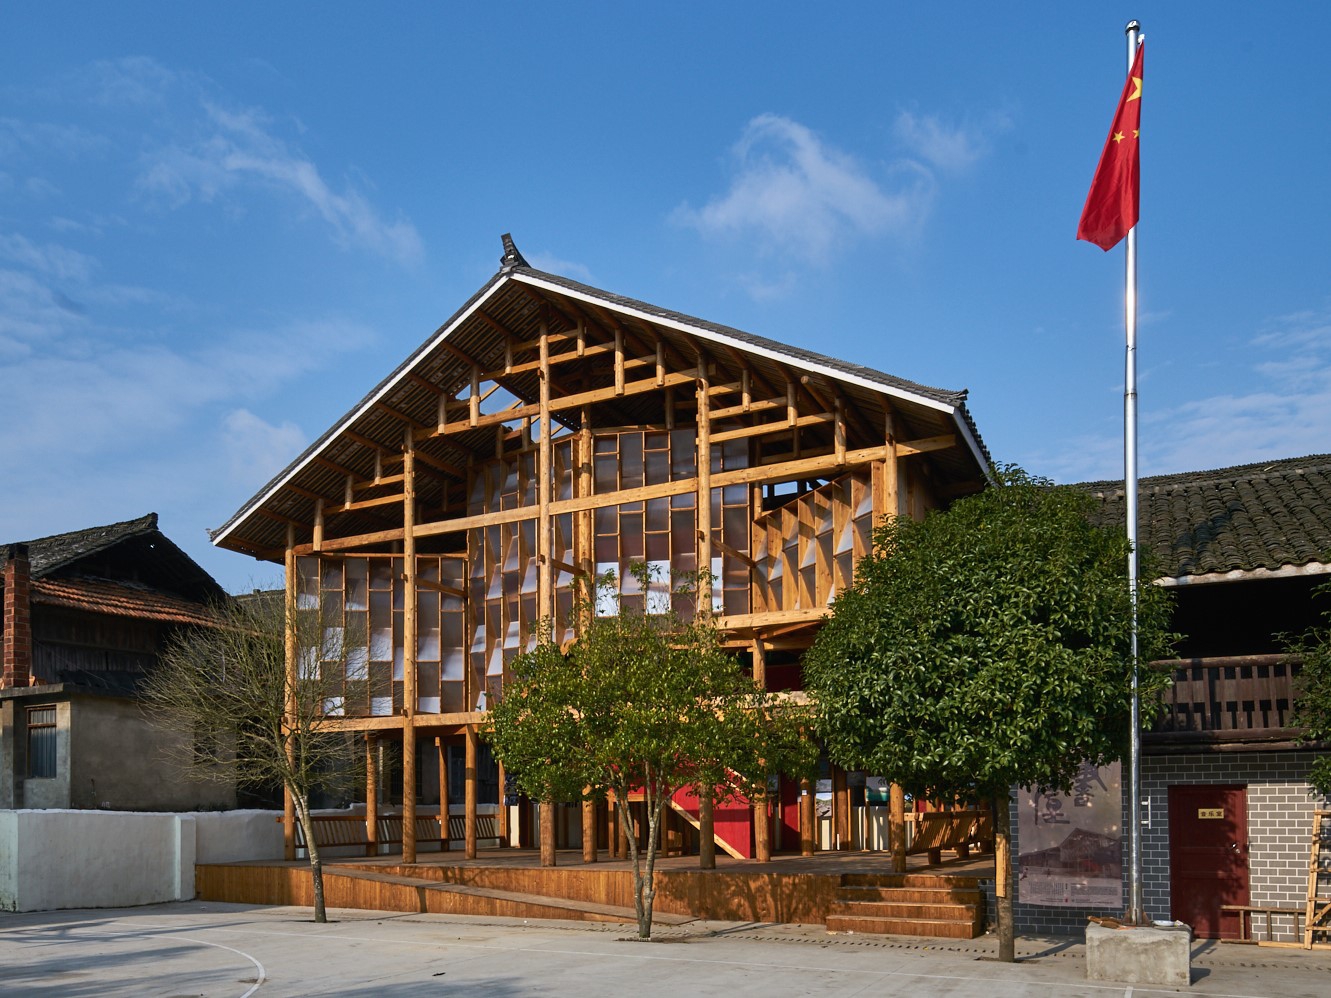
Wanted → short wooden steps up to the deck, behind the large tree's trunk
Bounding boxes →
[827,873,985,939]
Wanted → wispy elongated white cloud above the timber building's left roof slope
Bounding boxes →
[138,102,423,265]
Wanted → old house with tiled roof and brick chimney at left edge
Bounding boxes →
[0,514,234,809]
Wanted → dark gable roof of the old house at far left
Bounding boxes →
[0,512,225,603]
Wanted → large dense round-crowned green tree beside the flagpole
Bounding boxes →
[805,467,1170,961]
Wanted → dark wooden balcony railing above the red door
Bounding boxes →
[1145,655,1300,748]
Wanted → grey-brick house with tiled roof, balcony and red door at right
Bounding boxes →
[1028,454,1331,939]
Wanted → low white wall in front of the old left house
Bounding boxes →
[0,810,282,912]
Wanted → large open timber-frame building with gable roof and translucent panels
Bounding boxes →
[213,236,989,861]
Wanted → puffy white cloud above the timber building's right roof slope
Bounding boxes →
[673,114,936,265]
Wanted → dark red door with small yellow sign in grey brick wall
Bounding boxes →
[1169,785,1250,939]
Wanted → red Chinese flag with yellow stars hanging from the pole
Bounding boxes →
[1077,44,1146,250]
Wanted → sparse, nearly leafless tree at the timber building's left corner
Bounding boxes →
[144,593,363,922]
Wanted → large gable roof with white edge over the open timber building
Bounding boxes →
[210,238,990,558]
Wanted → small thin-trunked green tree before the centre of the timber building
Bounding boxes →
[487,567,812,939]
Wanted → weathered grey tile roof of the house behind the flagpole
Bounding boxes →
[1077,454,1331,578]
